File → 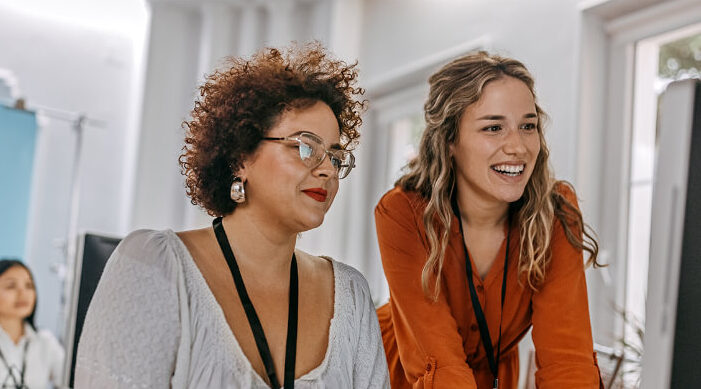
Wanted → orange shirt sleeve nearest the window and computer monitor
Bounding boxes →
[532,188,599,389]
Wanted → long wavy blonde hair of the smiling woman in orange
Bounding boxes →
[396,51,601,300]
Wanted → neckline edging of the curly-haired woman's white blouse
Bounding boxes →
[167,230,340,388]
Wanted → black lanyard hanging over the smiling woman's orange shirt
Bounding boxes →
[453,198,511,389]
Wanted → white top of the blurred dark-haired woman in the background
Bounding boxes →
[0,323,64,389]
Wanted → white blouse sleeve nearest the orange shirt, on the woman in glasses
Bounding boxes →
[349,268,389,389]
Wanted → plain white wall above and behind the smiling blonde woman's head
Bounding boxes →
[360,0,579,180]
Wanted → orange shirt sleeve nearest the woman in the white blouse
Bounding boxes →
[375,189,477,389]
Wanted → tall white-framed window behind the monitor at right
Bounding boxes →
[577,0,701,387]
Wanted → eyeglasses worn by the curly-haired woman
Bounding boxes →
[263,132,355,179]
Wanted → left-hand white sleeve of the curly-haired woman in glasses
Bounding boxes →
[75,231,180,389]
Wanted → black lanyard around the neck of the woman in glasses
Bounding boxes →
[212,217,299,389]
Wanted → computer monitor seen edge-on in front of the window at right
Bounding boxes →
[641,80,701,389]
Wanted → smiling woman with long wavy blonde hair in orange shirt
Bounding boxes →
[375,52,600,389]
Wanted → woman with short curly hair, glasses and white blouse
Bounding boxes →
[76,44,389,389]
